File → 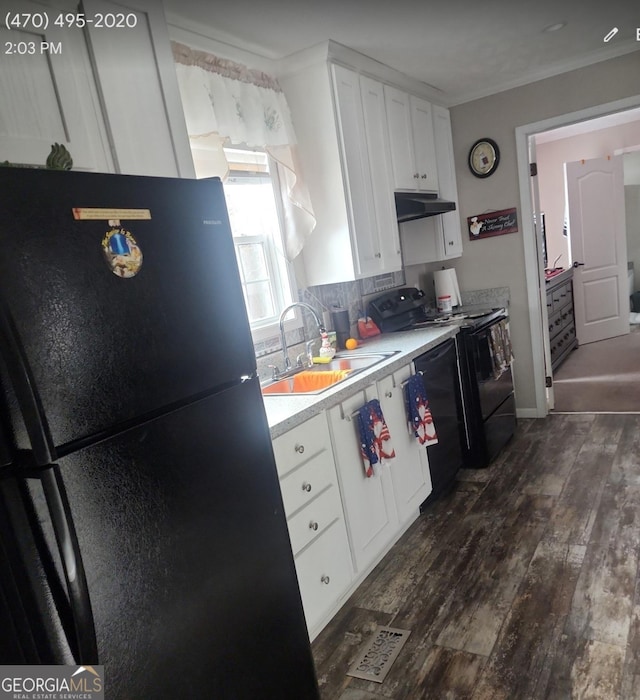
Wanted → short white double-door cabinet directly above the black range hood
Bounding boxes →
[384,85,438,192]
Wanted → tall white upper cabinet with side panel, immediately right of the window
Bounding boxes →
[279,59,402,285]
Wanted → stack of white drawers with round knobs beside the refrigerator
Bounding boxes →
[273,412,353,638]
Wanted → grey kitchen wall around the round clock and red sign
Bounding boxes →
[451,51,640,415]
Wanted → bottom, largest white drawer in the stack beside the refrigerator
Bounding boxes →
[295,520,352,631]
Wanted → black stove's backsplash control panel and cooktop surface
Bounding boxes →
[367,287,504,333]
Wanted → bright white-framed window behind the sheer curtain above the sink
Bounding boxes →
[224,148,292,338]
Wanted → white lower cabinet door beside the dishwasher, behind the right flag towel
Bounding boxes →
[378,365,431,523]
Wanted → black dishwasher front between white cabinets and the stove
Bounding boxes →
[414,338,464,510]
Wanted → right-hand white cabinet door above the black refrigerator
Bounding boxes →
[83,0,195,177]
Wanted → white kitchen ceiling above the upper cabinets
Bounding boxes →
[164,0,640,105]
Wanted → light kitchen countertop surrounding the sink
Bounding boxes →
[263,324,459,439]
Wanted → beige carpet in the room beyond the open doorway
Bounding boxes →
[553,325,640,413]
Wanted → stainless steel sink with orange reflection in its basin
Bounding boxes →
[262,350,399,396]
